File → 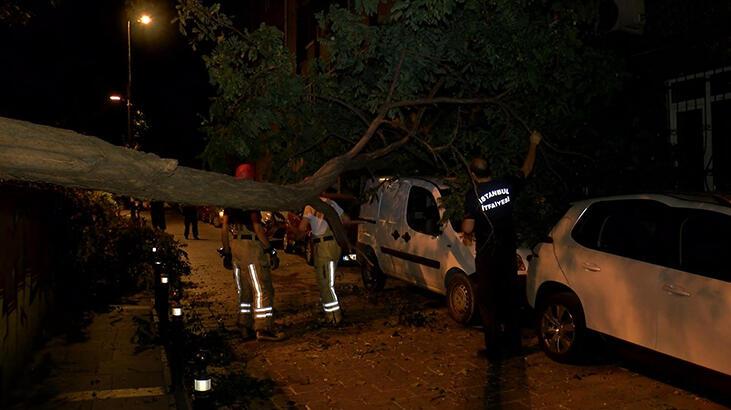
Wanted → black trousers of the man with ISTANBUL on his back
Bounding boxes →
[475,245,521,357]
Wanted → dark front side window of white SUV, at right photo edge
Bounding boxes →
[680,210,731,282]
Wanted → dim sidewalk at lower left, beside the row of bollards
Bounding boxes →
[10,294,176,410]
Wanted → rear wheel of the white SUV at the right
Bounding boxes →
[538,292,586,362]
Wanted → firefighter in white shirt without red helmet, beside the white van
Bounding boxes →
[298,197,350,325]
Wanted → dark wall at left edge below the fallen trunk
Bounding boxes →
[0,184,58,407]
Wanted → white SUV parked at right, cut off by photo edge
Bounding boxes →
[526,195,731,374]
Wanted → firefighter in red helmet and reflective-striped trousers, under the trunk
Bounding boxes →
[221,164,285,341]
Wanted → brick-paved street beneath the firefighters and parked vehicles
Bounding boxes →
[177,215,723,410]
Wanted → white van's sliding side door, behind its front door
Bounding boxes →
[376,180,411,278]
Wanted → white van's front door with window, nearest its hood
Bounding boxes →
[399,181,449,291]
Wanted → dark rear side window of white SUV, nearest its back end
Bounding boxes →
[571,199,677,265]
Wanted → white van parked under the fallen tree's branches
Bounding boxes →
[358,178,530,324]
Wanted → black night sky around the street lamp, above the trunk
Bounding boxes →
[0,0,212,166]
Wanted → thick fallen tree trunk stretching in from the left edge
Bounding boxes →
[0,117,350,247]
